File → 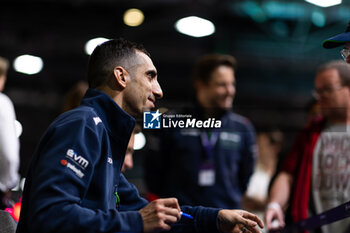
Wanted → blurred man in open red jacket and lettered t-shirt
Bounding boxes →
[265,61,350,233]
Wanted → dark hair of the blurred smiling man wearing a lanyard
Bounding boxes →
[192,54,237,84]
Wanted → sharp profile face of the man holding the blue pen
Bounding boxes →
[123,52,163,116]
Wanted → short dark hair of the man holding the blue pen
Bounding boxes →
[87,38,150,88]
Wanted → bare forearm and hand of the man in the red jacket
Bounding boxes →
[265,171,293,229]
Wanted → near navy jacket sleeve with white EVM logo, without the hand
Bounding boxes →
[19,118,143,233]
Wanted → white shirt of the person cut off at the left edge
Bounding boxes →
[0,92,19,192]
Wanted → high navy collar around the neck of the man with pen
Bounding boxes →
[81,89,136,145]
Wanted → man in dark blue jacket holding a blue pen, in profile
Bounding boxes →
[17,39,263,233]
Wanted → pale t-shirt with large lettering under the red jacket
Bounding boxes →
[312,125,350,233]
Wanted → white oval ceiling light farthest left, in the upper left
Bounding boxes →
[13,54,44,75]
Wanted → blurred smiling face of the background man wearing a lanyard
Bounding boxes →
[198,65,236,109]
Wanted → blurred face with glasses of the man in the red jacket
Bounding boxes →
[315,69,349,117]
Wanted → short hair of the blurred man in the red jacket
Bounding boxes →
[317,60,350,86]
